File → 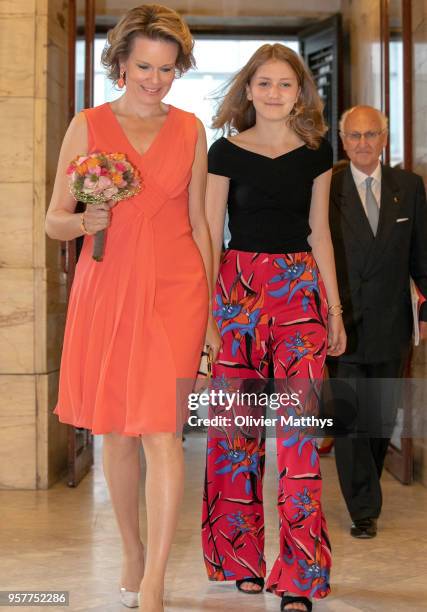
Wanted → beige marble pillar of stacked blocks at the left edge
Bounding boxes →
[0,0,68,489]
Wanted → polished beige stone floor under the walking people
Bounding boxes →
[0,436,427,612]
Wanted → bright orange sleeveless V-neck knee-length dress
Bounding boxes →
[54,103,208,436]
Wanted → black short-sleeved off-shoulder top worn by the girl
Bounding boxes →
[208,138,333,253]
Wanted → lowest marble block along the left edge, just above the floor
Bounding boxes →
[0,375,37,489]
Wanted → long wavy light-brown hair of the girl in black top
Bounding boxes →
[212,43,328,149]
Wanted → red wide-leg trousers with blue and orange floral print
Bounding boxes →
[202,250,331,598]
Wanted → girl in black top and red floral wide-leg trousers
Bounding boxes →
[202,44,346,612]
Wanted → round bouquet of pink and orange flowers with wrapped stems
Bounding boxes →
[67,152,143,261]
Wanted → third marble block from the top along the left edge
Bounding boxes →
[0,183,33,268]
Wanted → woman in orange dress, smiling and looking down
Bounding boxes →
[46,5,220,612]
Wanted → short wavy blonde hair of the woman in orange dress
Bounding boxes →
[101,4,195,83]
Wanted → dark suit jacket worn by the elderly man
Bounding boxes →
[329,166,427,363]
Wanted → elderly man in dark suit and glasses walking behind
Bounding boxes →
[328,106,427,538]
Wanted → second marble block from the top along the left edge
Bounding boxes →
[0,97,34,183]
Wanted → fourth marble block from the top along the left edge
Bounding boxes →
[0,268,34,374]
